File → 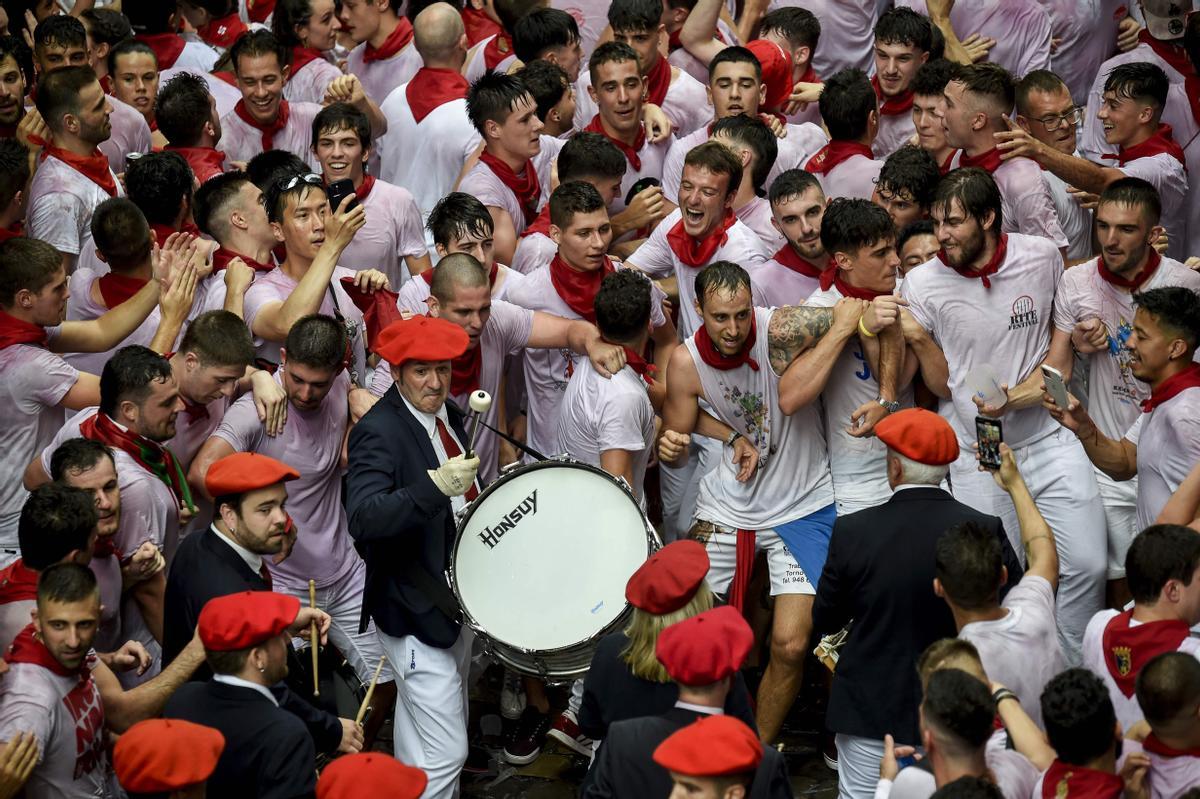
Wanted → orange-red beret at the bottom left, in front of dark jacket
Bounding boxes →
[113,719,224,793]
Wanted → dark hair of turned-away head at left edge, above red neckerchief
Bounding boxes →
[17,482,100,571]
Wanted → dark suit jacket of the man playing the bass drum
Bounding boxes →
[346,385,467,649]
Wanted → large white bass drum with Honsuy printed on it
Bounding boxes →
[450,461,661,683]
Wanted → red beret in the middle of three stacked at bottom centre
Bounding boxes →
[654,605,754,685]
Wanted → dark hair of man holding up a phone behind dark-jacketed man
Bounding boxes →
[934,522,1004,611]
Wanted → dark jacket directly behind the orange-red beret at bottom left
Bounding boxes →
[163,681,317,799]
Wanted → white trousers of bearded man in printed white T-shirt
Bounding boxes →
[950,428,1108,666]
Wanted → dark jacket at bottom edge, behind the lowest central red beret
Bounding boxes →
[581,708,792,799]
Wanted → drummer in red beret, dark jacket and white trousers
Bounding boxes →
[346,317,479,799]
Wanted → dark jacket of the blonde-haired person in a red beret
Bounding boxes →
[578,632,758,740]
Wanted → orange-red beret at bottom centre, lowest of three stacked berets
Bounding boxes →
[654,715,762,777]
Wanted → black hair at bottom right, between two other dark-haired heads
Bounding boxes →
[1042,668,1117,765]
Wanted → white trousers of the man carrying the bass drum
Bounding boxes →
[378,627,474,799]
